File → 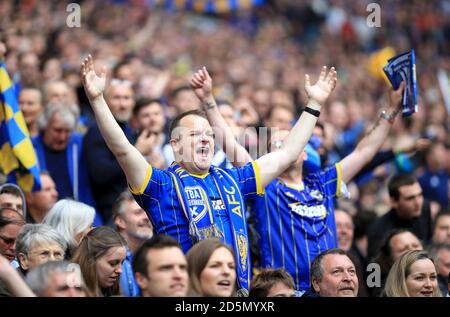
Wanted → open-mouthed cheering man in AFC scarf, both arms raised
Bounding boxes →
[81,55,336,294]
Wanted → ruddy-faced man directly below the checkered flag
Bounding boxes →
[25,171,58,223]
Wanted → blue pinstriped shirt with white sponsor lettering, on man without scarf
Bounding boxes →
[252,163,341,290]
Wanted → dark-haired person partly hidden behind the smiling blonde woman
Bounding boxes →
[370,229,423,296]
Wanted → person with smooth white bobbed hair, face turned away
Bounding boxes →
[43,199,95,259]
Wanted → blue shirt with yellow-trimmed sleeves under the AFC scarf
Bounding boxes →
[131,161,263,252]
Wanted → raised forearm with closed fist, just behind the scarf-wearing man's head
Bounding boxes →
[191,67,252,166]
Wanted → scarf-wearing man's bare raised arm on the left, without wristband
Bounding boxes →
[81,55,149,190]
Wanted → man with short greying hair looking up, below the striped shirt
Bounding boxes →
[311,249,359,297]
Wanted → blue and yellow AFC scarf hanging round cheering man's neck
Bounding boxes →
[168,162,250,295]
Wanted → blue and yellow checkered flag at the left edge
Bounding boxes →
[0,62,41,192]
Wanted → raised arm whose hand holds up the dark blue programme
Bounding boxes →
[340,82,405,182]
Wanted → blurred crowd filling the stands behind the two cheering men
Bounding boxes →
[0,0,450,296]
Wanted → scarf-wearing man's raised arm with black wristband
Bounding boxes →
[258,66,337,186]
